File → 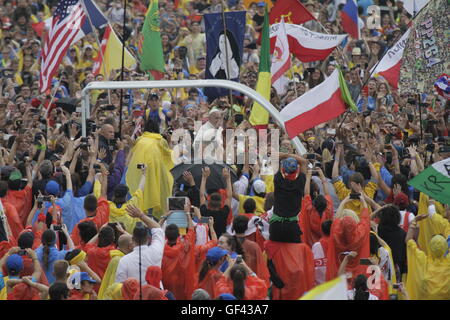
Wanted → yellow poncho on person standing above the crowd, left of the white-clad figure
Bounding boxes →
[126,132,174,218]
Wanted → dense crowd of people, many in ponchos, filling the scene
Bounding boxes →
[0,0,450,300]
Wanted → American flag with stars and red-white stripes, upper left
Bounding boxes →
[39,0,86,92]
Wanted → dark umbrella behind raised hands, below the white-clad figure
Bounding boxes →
[171,161,238,190]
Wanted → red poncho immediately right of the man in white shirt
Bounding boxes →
[161,229,198,300]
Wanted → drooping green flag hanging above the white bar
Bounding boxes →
[139,0,165,80]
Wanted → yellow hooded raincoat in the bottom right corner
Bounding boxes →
[406,235,450,300]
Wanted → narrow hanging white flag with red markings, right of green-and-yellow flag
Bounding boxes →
[270,19,291,94]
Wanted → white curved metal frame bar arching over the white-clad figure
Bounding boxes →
[81,80,306,154]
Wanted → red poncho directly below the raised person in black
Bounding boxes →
[265,240,314,300]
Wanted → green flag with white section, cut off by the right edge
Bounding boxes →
[408,158,450,204]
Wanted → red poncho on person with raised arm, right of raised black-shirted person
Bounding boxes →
[327,208,370,280]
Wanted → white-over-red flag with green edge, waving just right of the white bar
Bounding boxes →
[280,68,357,139]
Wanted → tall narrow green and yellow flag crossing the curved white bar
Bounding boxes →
[249,6,272,128]
